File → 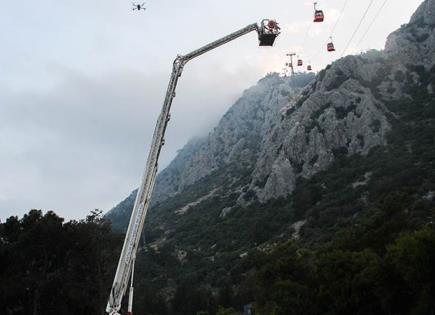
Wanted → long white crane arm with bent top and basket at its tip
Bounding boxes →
[106,20,279,315]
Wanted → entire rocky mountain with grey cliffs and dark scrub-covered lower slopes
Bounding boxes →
[107,0,435,314]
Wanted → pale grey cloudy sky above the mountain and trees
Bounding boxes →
[0,0,421,220]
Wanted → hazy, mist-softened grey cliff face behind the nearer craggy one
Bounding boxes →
[150,74,313,207]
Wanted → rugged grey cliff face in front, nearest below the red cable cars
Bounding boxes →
[247,56,390,202]
